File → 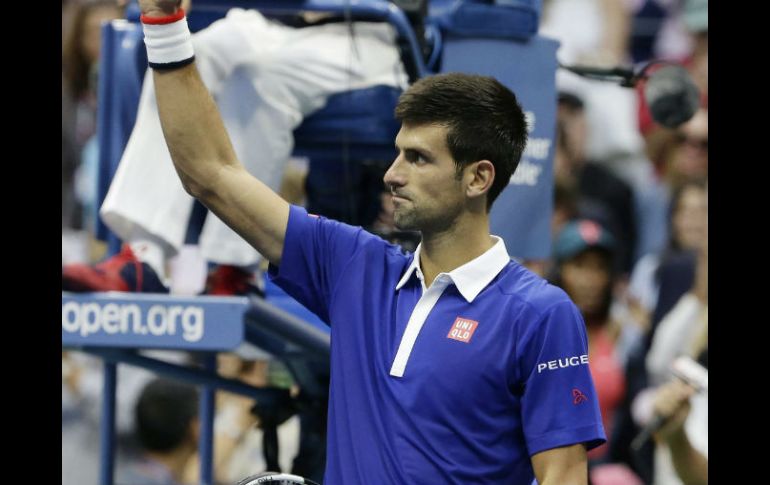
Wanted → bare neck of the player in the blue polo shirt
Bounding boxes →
[419,216,495,287]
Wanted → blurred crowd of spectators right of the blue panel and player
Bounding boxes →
[537,0,708,485]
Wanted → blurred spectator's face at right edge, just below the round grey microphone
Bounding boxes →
[671,109,709,180]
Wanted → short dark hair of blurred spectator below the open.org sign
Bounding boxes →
[136,379,198,452]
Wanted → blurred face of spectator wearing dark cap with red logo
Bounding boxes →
[561,249,611,317]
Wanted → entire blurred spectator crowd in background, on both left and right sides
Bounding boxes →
[62,0,708,485]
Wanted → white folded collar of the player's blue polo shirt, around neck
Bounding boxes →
[396,236,511,303]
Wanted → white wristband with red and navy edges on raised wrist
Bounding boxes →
[142,12,195,69]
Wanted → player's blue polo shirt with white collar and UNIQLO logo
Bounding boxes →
[270,206,605,485]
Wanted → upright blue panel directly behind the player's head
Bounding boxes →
[441,36,559,259]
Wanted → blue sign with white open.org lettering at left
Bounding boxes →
[61,292,248,351]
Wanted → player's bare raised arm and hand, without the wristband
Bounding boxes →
[140,0,289,265]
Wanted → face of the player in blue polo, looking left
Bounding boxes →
[383,123,465,232]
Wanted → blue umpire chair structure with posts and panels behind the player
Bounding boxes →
[69,0,557,485]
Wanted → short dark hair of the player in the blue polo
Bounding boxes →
[396,73,527,209]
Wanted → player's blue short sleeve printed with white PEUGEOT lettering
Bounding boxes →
[517,299,606,455]
